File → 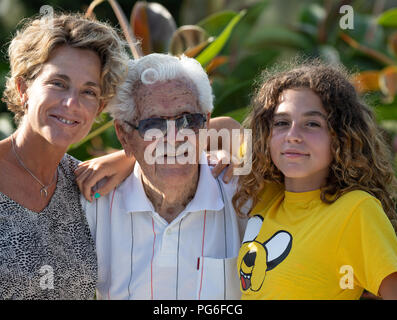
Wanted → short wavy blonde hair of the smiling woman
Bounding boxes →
[3,14,128,123]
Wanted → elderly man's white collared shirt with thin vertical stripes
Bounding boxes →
[82,155,246,299]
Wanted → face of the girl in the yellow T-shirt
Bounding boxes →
[270,88,332,192]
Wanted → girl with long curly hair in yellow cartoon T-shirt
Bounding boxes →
[233,61,397,299]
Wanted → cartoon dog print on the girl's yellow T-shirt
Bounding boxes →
[238,215,292,291]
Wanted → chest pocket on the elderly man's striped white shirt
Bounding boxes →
[196,257,241,300]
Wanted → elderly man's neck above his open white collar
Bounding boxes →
[142,166,200,223]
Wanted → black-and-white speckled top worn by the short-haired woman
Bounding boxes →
[0,154,97,300]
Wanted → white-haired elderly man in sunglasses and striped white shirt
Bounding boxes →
[85,54,245,299]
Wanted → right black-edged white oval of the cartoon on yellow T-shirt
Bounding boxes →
[263,230,292,271]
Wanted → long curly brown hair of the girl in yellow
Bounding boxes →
[233,60,397,229]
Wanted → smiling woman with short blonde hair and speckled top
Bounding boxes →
[0,14,128,299]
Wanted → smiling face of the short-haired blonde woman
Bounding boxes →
[20,45,101,148]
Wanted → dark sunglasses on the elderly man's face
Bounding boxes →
[124,113,207,138]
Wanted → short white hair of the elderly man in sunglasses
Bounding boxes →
[106,53,214,120]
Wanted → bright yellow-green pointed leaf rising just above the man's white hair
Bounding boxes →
[196,10,246,67]
